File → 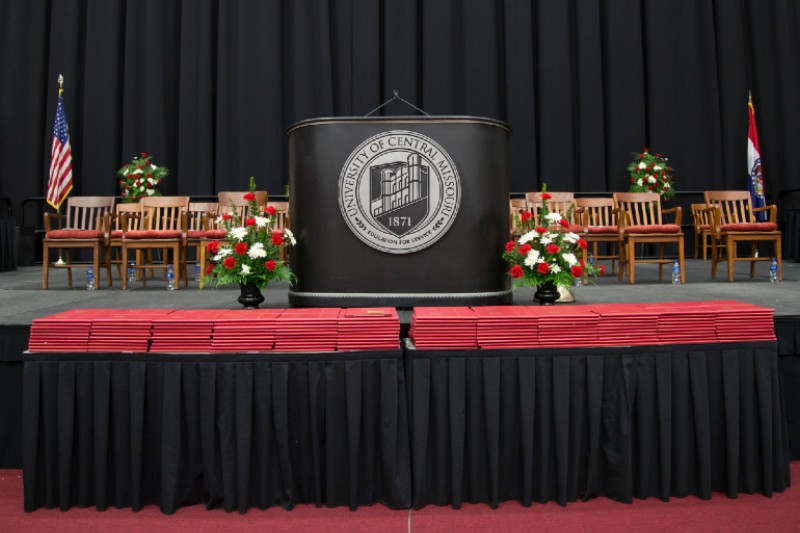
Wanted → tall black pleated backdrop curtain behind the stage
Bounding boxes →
[0,0,800,210]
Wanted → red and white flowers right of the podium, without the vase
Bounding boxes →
[503,184,605,287]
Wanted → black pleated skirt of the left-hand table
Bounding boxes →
[23,350,411,513]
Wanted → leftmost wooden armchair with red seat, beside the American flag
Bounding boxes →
[42,196,114,289]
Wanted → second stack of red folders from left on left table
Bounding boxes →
[88,309,175,353]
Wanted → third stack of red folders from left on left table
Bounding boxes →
[150,309,226,353]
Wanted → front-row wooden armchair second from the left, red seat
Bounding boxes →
[122,196,189,289]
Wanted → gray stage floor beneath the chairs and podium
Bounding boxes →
[0,260,800,325]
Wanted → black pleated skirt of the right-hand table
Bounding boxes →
[405,342,790,508]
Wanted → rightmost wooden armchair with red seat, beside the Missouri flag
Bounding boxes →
[704,191,783,281]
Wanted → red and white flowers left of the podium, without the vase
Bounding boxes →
[204,178,297,290]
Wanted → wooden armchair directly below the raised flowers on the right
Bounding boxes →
[613,192,686,283]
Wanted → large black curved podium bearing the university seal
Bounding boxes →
[287,117,511,307]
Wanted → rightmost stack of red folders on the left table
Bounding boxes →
[337,307,400,352]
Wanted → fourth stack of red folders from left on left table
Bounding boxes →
[211,309,284,353]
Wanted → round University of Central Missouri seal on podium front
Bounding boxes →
[339,131,461,254]
